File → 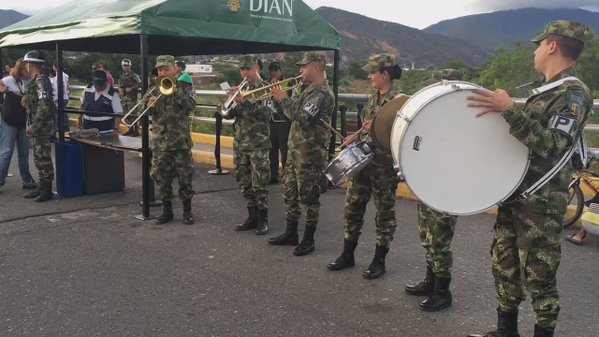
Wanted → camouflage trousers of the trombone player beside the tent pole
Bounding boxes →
[150,150,195,201]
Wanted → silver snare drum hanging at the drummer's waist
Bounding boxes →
[324,141,374,185]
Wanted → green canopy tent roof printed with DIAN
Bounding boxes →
[0,0,341,55]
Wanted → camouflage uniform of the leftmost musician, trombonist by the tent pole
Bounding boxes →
[139,64,195,201]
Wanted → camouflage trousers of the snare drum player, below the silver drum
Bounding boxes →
[344,164,399,247]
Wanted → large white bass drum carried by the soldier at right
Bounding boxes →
[390,81,529,215]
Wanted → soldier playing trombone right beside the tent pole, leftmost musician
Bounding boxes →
[139,55,195,225]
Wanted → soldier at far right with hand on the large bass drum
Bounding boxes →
[468,21,593,337]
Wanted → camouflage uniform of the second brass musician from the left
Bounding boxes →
[226,55,271,209]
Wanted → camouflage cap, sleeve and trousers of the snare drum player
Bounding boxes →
[345,58,399,248]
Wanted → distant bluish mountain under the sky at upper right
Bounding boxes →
[424,8,599,52]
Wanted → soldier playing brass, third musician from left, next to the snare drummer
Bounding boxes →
[268,52,335,256]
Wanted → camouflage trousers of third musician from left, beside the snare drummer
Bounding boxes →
[283,160,324,226]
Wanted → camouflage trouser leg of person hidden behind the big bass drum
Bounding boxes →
[418,202,457,278]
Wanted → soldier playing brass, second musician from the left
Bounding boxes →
[226,55,271,235]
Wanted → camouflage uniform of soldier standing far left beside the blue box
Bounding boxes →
[26,74,56,186]
